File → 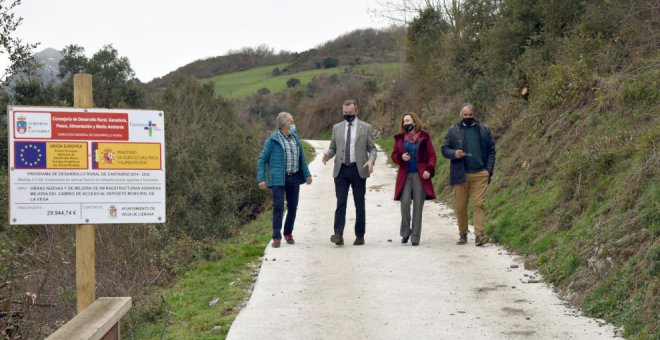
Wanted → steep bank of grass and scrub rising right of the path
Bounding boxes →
[235,0,660,339]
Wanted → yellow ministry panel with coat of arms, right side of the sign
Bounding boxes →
[94,143,161,170]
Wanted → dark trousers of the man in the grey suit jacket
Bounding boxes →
[334,164,367,237]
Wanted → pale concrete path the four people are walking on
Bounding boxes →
[227,141,615,340]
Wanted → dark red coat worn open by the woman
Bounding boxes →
[392,130,436,201]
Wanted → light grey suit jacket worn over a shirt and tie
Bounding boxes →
[326,118,376,179]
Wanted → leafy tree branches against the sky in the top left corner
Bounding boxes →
[0,0,39,84]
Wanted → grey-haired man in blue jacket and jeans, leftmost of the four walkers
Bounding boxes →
[257,112,312,248]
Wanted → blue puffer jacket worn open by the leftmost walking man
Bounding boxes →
[257,131,312,188]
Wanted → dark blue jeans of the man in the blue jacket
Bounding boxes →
[271,176,300,239]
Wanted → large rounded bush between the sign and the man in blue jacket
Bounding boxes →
[159,78,266,239]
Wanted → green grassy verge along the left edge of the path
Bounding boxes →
[129,141,314,339]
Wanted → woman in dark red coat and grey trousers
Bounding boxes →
[392,112,436,246]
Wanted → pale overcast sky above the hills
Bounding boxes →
[0,0,389,82]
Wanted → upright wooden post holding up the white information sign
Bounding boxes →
[73,74,96,313]
